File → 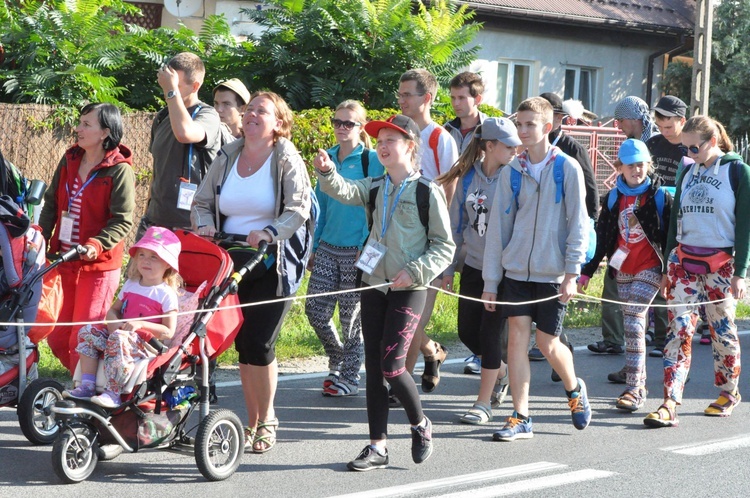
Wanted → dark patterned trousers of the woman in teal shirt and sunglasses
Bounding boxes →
[305,242,363,385]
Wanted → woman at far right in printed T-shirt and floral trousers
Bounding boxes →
[643,116,750,427]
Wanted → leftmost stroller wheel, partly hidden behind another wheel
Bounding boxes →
[18,379,64,444]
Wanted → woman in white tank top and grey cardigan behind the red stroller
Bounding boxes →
[191,92,311,453]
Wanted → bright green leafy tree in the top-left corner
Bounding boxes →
[0,0,137,122]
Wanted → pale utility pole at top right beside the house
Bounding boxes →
[690,0,714,116]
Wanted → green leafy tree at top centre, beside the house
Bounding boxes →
[244,0,480,109]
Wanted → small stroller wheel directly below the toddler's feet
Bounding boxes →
[52,426,99,484]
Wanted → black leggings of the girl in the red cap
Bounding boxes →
[362,289,427,440]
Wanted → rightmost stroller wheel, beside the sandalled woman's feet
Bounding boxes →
[195,409,245,481]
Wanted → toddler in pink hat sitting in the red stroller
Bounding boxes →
[63,226,181,408]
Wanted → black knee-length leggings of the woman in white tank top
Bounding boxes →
[234,265,292,367]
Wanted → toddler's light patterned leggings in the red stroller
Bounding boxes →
[76,325,151,394]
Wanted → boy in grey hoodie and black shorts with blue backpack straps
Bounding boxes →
[482,97,591,441]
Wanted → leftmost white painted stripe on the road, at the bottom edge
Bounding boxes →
[326,462,567,498]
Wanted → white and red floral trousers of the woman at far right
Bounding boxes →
[664,250,740,403]
